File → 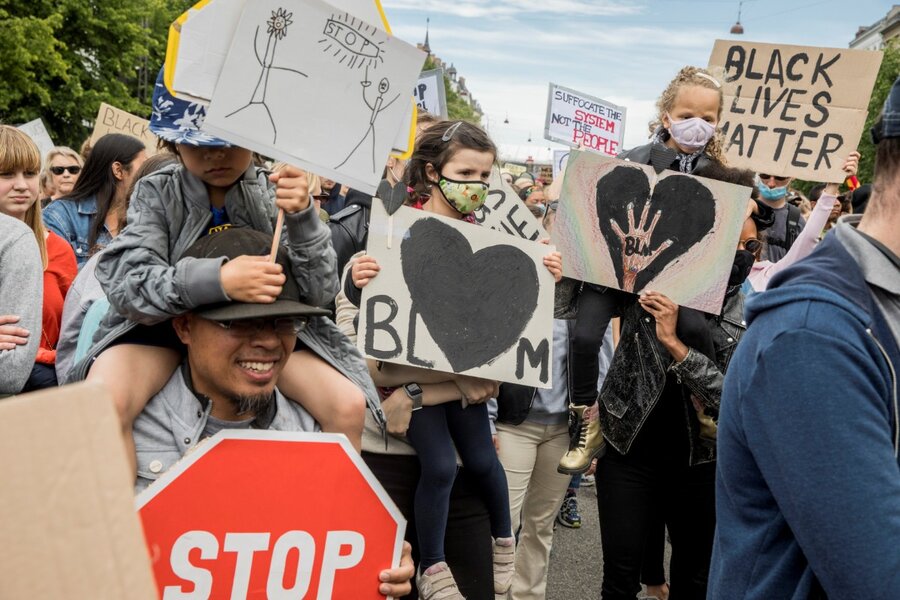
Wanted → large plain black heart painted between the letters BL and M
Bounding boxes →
[400,218,538,372]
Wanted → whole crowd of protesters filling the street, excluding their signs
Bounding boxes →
[0,62,900,600]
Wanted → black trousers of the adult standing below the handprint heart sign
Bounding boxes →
[597,398,716,600]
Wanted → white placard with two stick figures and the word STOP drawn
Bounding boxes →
[204,0,426,194]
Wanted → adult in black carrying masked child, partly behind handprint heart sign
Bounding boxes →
[597,165,771,599]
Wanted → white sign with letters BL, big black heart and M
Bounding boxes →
[358,202,554,388]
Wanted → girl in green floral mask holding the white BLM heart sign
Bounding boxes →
[348,121,562,600]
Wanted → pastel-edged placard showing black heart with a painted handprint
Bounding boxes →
[552,151,750,314]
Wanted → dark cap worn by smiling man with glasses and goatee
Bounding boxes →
[183,227,331,321]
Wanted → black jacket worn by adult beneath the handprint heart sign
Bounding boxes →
[600,292,747,465]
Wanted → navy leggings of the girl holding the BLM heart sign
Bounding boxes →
[406,402,512,571]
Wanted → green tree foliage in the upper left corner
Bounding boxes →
[0,0,192,148]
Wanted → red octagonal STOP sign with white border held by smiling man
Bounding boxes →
[137,430,406,600]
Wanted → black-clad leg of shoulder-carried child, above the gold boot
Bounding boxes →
[569,284,622,406]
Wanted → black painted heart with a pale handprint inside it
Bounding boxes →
[596,166,716,293]
